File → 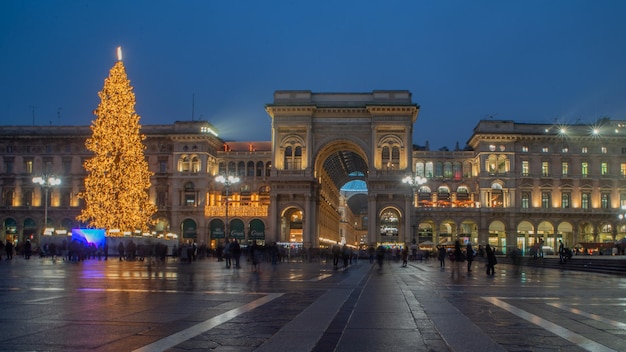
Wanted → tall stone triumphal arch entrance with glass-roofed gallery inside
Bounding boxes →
[265,90,419,248]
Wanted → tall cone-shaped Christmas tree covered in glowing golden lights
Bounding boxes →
[77,48,156,235]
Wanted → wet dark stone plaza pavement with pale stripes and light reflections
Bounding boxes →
[0,254,626,352]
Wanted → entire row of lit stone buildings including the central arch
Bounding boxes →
[0,91,626,252]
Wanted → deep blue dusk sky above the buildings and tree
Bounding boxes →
[0,0,626,149]
